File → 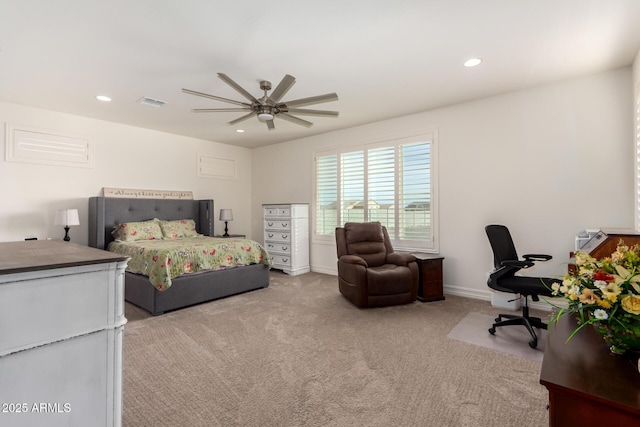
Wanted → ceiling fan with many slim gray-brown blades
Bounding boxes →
[182,73,338,130]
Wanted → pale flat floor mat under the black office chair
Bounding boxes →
[447,313,547,363]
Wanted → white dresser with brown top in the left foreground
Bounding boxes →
[0,241,127,427]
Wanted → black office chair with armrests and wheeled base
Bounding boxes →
[485,225,562,348]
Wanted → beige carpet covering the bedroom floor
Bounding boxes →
[123,272,548,427]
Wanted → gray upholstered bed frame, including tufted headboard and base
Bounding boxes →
[89,197,269,316]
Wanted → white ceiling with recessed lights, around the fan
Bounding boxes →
[0,0,640,147]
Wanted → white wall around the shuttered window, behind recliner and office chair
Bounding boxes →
[252,68,634,298]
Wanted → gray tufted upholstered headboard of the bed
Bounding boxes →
[89,197,214,249]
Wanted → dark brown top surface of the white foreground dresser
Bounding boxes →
[0,240,127,274]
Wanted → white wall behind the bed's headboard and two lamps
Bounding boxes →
[0,102,252,244]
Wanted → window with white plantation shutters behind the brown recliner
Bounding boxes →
[314,133,438,251]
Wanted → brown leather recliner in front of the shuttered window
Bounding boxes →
[336,222,418,307]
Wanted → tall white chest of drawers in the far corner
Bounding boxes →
[262,203,311,276]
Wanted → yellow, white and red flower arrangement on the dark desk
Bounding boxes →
[551,241,640,353]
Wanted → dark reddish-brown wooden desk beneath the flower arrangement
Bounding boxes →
[540,316,640,427]
